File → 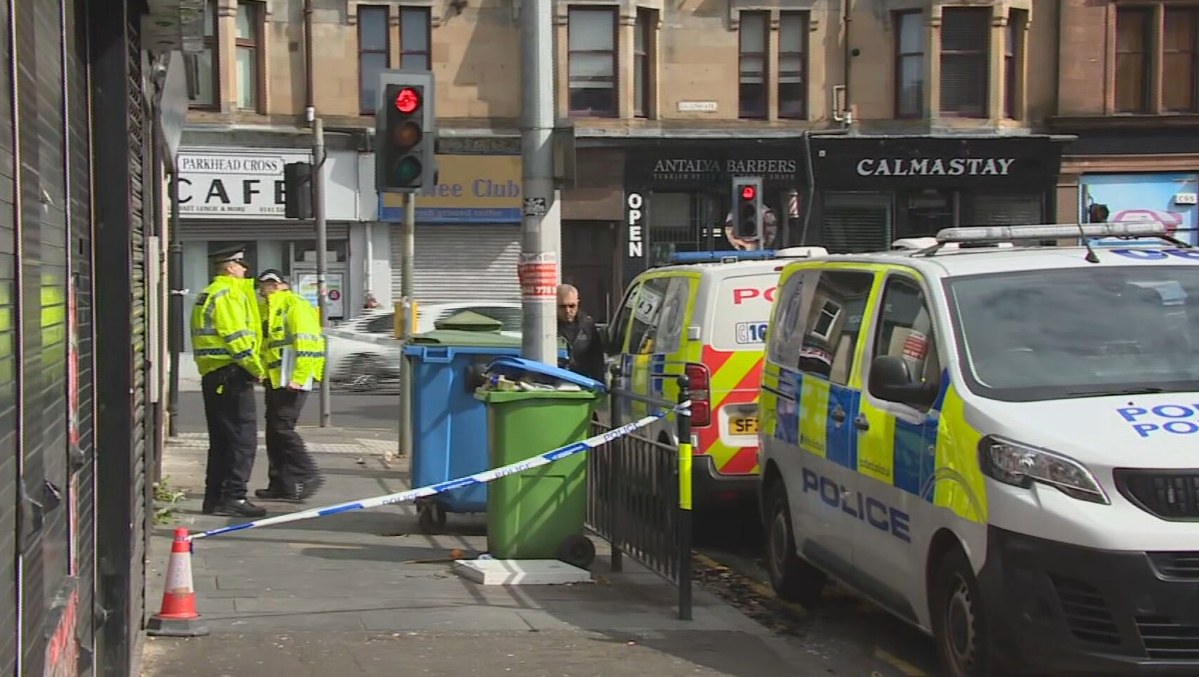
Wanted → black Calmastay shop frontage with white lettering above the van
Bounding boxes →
[789,135,1073,253]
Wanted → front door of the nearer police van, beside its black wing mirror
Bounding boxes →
[856,272,941,610]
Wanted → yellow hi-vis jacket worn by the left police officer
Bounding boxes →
[192,276,266,379]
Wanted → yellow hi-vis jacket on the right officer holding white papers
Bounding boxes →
[261,289,325,389]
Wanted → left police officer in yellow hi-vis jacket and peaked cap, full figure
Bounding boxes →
[191,247,266,518]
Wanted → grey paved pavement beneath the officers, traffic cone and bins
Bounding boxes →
[141,429,848,677]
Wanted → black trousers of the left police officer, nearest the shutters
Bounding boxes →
[200,364,258,507]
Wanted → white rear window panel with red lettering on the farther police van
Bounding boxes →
[710,272,778,350]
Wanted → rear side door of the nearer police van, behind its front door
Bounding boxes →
[788,270,875,578]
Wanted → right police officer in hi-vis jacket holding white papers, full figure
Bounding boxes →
[254,270,325,502]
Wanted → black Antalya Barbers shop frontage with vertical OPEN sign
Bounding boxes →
[621,137,806,283]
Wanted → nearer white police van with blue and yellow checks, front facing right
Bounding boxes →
[759,223,1199,677]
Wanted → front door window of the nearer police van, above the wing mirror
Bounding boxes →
[872,276,941,397]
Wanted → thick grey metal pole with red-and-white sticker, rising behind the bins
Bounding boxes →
[518,0,558,367]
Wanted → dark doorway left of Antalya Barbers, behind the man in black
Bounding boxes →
[562,222,620,322]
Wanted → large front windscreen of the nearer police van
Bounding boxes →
[945,265,1199,401]
